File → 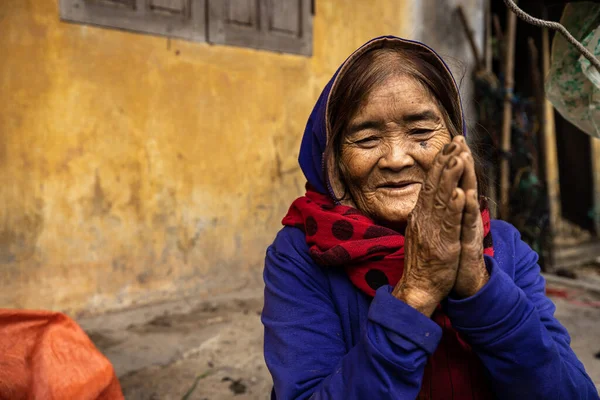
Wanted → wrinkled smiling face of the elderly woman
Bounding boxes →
[340,76,451,227]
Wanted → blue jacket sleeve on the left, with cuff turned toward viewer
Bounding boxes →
[262,247,442,400]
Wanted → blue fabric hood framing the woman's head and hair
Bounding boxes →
[298,36,466,199]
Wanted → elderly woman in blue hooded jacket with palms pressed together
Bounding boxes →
[262,37,598,400]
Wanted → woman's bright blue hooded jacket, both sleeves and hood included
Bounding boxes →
[262,37,599,400]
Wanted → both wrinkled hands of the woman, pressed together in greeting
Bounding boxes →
[392,136,489,316]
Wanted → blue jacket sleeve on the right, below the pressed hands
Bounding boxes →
[448,228,598,400]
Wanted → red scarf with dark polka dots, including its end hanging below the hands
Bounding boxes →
[282,189,494,400]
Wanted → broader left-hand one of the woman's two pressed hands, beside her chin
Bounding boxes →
[393,137,474,316]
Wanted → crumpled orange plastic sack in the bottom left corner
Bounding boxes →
[0,309,124,400]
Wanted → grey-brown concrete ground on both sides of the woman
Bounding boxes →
[79,276,600,400]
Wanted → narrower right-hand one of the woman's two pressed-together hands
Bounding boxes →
[452,136,489,298]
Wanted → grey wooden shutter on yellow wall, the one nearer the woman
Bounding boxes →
[208,0,312,55]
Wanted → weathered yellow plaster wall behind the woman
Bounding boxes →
[0,0,407,313]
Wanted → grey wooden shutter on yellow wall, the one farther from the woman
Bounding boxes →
[60,0,206,41]
